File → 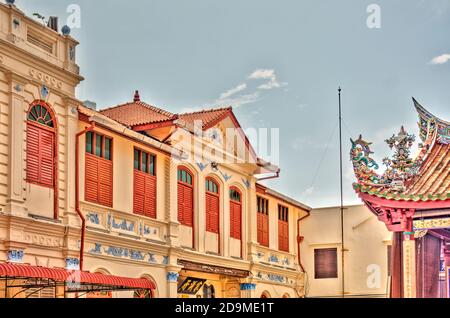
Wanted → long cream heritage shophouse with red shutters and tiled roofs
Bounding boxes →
[0,4,310,297]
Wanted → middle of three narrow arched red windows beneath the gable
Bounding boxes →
[205,178,220,234]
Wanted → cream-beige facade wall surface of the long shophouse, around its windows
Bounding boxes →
[0,4,305,297]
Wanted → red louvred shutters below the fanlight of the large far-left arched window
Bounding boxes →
[27,122,55,187]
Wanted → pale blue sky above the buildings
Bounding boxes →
[16,0,450,207]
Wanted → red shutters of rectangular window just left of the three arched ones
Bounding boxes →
[133,170,156,219]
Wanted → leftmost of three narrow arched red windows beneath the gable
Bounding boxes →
[178,167,194,227]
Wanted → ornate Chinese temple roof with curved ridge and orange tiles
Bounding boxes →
[351,99,450,202]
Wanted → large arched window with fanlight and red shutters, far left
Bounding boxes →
[26,101,56,188]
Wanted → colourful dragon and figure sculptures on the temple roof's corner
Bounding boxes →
[350,126,422,193]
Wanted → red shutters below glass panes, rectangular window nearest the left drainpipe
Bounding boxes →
[85,153,113,207]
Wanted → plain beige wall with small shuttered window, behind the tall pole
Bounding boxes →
[301,205,391,297]
